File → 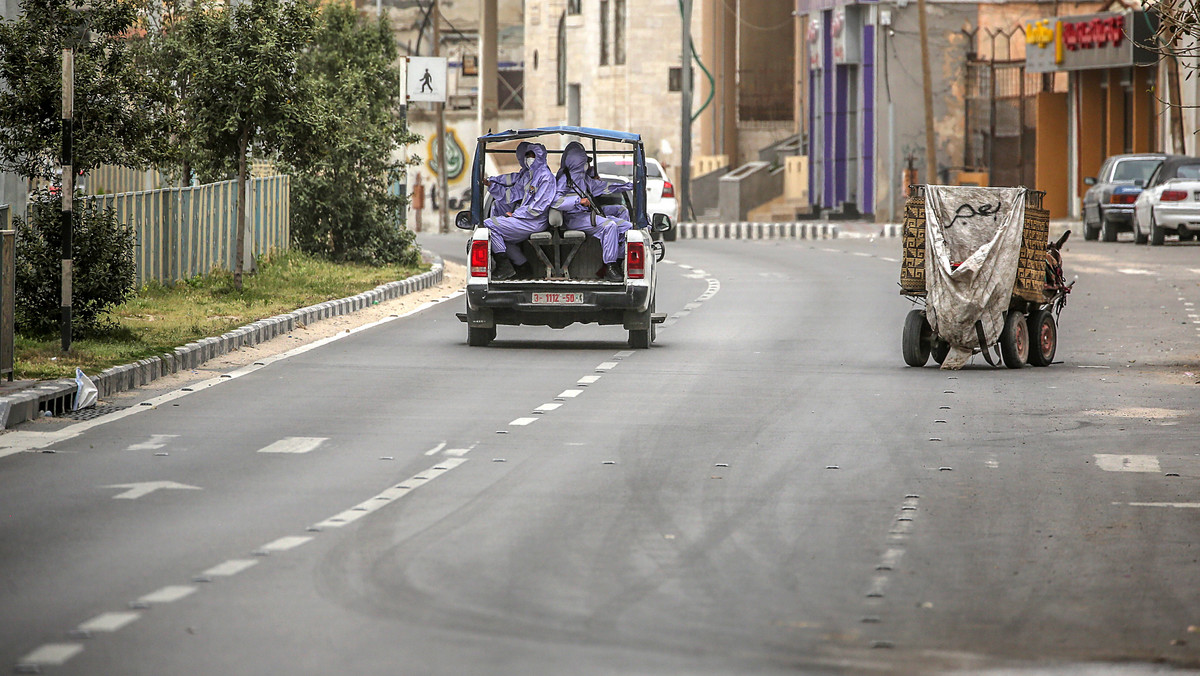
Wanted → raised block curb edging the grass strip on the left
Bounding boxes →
[0,257,445,430]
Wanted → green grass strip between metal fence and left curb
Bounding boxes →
[14,252,428,379]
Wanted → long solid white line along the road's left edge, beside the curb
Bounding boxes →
[0,291,467,457]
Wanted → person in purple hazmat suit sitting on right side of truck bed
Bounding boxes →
[553,140,634,282]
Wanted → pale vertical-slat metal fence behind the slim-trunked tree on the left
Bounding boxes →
[84,177,292,286]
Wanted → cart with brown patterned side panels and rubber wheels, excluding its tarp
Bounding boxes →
[900,185,1074,369]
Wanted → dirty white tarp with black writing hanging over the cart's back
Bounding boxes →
[925,185,1025,369]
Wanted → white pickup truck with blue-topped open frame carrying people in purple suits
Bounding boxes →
[455,126,672,348]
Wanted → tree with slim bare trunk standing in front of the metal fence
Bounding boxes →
[181,0,323,291]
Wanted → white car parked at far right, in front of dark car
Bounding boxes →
[1133,155,1200,246]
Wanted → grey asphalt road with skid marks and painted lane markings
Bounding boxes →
[0,230,1200,675]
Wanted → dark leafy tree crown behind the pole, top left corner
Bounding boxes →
[0,0,167,179]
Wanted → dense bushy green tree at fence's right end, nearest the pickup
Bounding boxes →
[289,2,418,263]
